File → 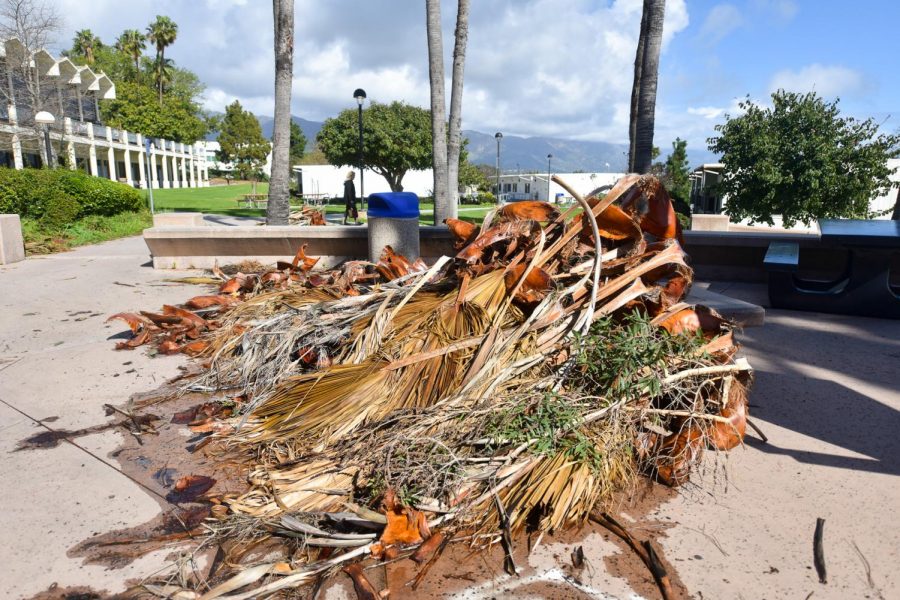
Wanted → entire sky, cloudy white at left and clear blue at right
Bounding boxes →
[49,0,900,162]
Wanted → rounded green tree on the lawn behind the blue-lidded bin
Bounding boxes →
[316,102,431,192]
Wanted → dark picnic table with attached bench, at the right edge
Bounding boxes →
[765,219,900,319]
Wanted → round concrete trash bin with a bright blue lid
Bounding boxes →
[366,192,419,262]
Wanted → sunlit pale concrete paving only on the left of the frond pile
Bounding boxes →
[0,237,202,598]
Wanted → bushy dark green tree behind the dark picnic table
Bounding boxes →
[708,90,900,227]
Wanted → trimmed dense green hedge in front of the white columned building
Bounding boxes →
[0,167,144,224]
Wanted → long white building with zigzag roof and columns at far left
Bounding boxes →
[0,38,209,188]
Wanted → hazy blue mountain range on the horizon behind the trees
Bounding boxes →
[206,115,716,173]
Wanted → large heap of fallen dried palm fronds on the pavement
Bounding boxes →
[110,176,750,598]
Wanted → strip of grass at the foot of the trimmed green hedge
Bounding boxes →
[22,211,153,254]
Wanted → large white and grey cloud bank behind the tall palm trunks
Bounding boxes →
[51,0,689,142]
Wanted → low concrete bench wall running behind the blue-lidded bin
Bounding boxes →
[144,225,453,269]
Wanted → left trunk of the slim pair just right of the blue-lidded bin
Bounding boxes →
[425,0,450,225]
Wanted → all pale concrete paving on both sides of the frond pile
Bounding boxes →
[0,238,900,600]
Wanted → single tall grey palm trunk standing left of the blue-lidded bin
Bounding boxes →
[266,0,294,225]
